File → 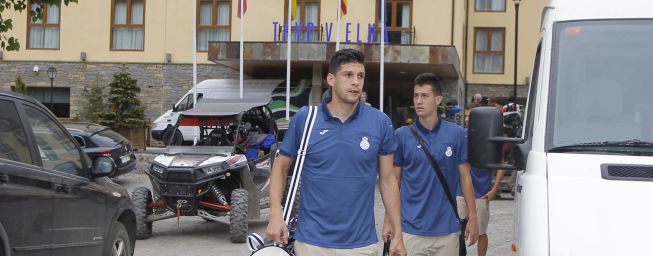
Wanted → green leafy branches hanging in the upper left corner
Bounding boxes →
[0,0,78,51]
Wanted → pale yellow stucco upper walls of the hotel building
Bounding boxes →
[2,0,546,87]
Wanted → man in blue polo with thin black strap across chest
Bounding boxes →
[383,73,478,256]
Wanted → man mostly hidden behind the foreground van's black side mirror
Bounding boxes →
[456,104,505,256]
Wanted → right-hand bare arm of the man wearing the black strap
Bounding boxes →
[458,163,478,246]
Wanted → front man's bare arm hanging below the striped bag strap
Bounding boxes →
[265,154,293,244]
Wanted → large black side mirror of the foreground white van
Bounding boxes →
[467,107,522,170]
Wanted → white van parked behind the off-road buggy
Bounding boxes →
[152,79,283,145]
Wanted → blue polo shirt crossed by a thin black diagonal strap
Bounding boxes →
[394,119,467,236]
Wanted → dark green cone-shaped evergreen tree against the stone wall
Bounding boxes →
[98,71,148,128]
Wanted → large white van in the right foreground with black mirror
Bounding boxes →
[469,0,653,256]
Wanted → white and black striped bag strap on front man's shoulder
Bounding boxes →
[283,106,317,225]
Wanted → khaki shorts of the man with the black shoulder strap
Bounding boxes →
[404,232,460,256]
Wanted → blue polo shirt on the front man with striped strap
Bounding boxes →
[280,98,397,249]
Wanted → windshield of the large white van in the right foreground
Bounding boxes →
[547,20,653,152]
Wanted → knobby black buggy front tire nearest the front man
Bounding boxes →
[229,188,249,243]
